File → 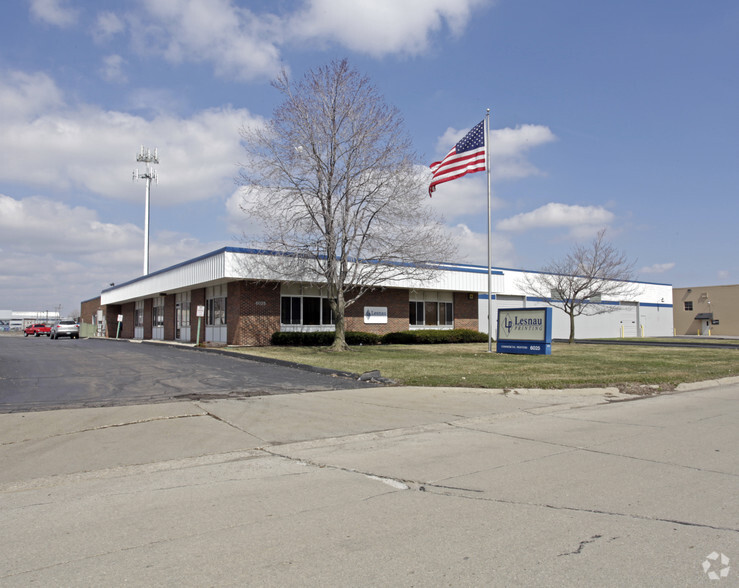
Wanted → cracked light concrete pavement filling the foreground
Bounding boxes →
[0,378,739,586]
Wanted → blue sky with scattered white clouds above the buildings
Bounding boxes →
[0,0,739,314]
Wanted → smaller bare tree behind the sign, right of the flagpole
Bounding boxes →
[521,229,637,343]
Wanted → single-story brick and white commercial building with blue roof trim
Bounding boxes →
[81,247,673,345]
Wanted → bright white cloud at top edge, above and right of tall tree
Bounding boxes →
[289,0,488,57]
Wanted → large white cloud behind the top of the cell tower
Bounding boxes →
[0,73,259,205]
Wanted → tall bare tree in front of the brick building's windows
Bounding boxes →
[240,60,455,350]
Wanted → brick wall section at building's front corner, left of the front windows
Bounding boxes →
[226,281,280,345]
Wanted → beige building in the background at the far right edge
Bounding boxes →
[672,284,739,336]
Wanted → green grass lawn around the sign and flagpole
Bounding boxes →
[234,343,739,390]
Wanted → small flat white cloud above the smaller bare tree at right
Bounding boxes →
[496,202,615,238]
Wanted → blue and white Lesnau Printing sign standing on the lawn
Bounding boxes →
[496,308,552,355]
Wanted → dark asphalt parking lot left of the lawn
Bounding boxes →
[0,335,373,413]
